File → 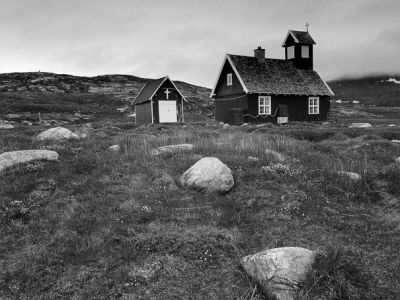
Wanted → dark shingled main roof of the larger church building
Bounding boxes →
[212,54,334,96]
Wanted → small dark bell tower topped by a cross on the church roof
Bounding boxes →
[282,26,316,70]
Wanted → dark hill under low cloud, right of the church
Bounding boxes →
[328,75,400,106]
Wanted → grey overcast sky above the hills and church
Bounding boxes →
[0,0,400,87]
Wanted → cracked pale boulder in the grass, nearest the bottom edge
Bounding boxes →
[241,247,315,300]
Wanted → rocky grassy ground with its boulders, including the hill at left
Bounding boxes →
[0,73,400,300]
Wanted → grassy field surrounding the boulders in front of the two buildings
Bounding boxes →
[0,119,400,299]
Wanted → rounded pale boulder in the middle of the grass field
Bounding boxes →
[179,157,234,193]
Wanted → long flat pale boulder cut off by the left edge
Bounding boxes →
[0,150,58,172]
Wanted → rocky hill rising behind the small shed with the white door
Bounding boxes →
[0,72,213,118]
